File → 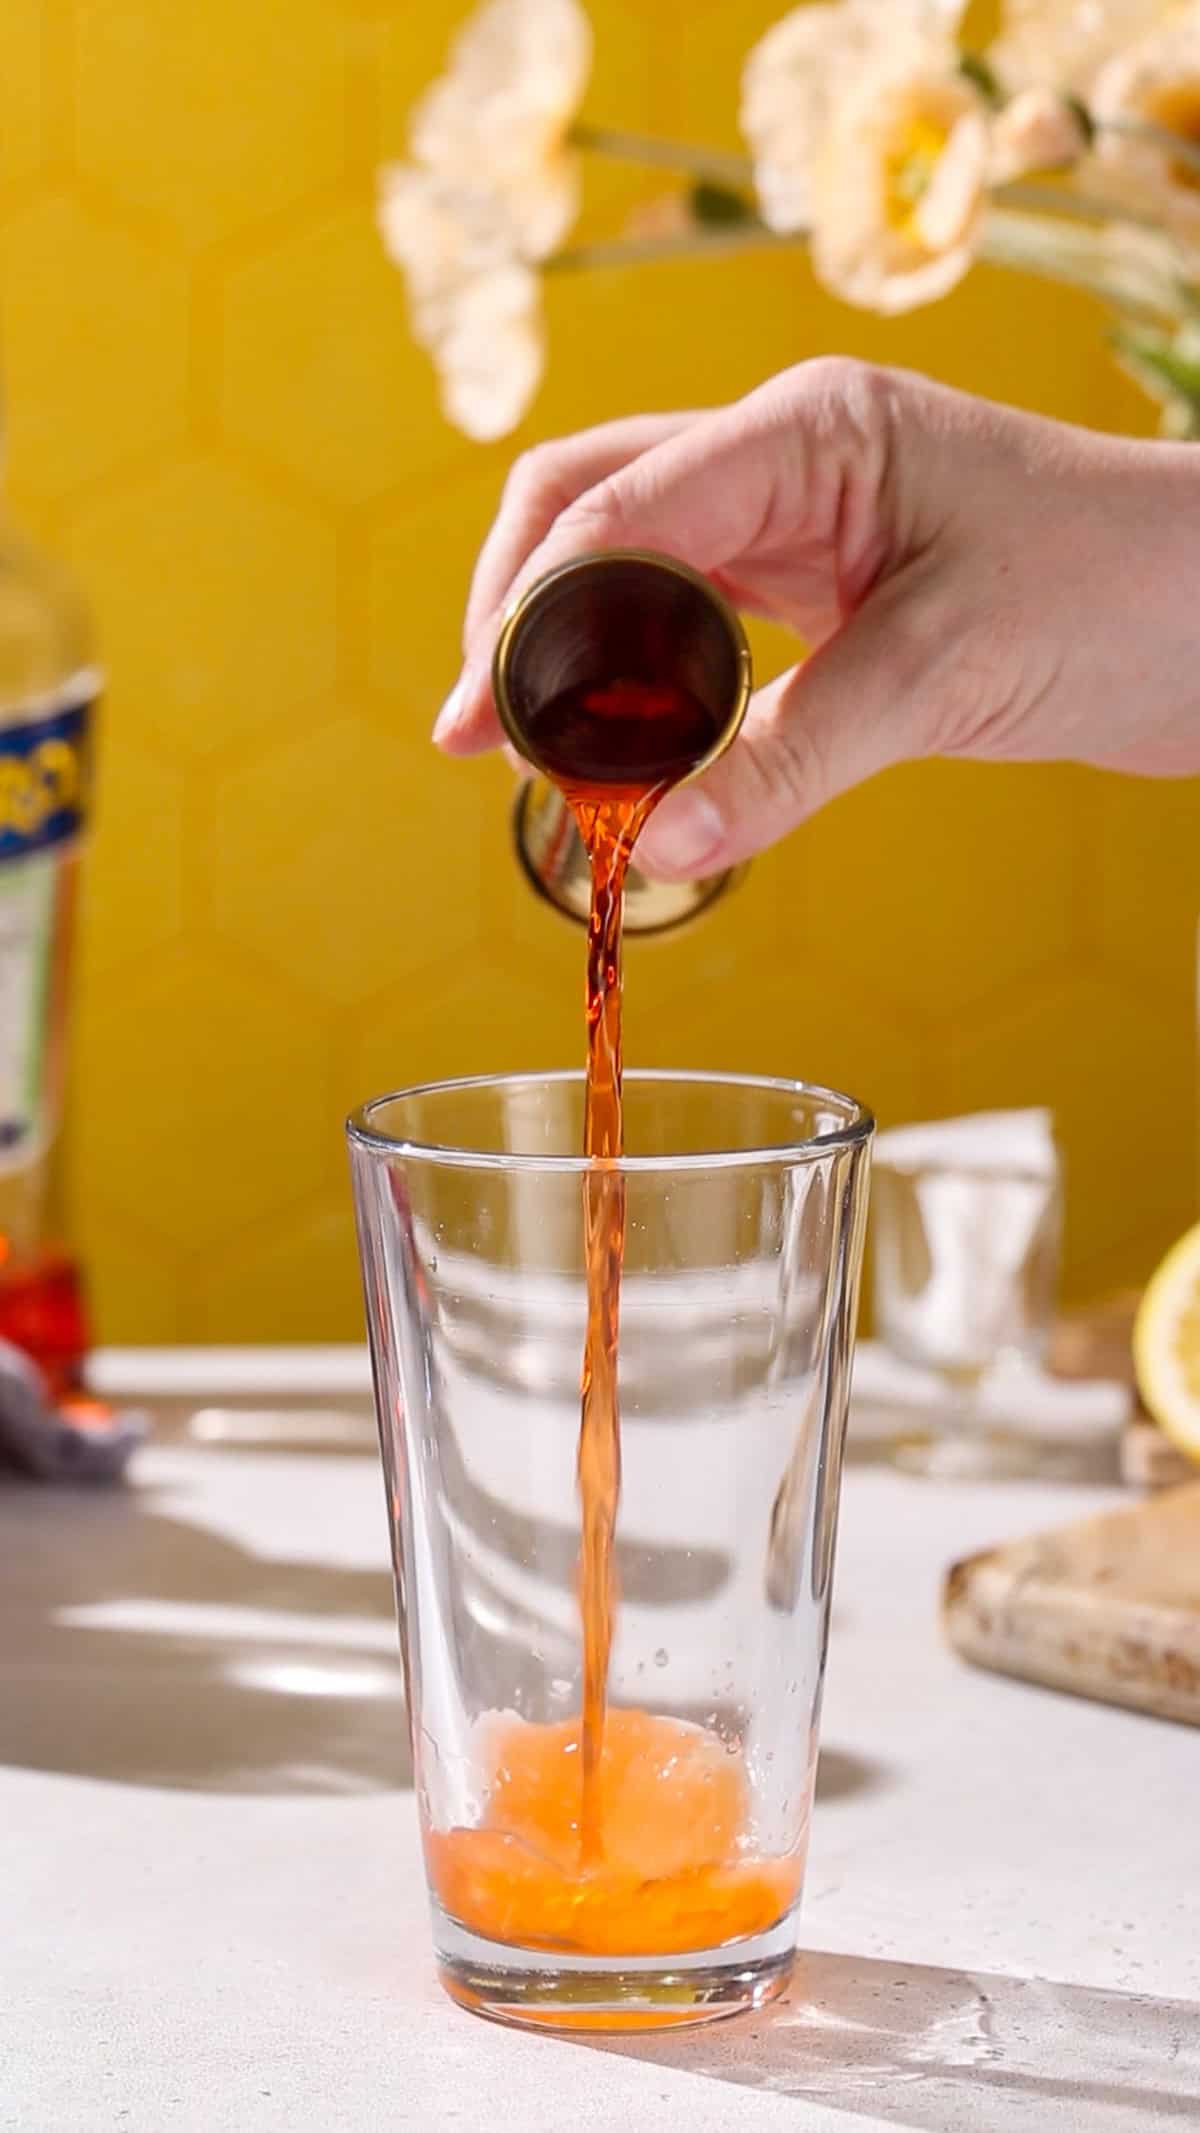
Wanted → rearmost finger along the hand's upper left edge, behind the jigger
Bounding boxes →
[463,414,695,653]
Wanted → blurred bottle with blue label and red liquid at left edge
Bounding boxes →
[0,441,98,1397]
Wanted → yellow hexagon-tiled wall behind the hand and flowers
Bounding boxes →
[0,0,1200,1340]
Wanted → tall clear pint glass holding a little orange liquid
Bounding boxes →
[350,1073,872,2028]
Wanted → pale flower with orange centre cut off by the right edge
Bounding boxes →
[1091,6,1200,239]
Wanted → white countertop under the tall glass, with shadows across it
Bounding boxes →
[0,1365,1200,2133]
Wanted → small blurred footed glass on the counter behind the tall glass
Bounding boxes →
[872,1111,1061,1480]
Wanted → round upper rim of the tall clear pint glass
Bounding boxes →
[345,1067,876,1177]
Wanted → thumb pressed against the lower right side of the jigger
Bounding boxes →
[637,582,929,881]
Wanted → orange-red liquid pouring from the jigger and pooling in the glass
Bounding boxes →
[426,683,801,1956]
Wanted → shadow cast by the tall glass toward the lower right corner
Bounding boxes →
[580,1952,1200,2133]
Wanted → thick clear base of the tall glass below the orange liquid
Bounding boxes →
[435,1905,795,2031]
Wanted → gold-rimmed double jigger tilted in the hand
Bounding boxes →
[492,548,752,934]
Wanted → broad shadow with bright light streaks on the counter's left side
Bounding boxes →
[0,1482,411,1794]
